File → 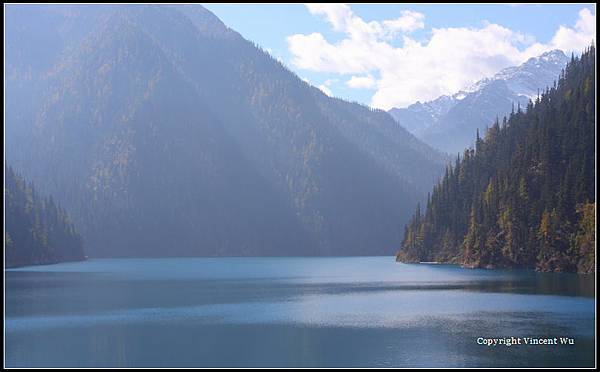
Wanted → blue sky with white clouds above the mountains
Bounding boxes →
[204,3,596,110]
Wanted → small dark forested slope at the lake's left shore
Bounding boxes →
[4,167,85,267]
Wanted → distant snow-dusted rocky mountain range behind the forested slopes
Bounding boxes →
[389,50,569,154]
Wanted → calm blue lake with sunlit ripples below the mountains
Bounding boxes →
[5,257,595,367]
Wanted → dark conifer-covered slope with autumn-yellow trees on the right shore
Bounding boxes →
[397,47,596,273]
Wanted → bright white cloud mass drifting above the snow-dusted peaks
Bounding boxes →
[287,4,596,109]
